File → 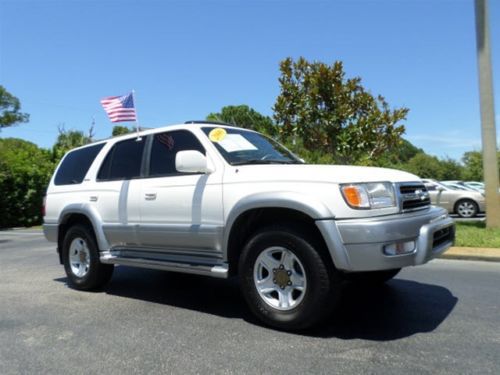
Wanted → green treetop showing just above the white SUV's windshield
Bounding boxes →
[207,105,277,136]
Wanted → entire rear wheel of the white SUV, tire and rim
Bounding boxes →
[62,225,113,290]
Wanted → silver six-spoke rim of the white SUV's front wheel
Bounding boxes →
[253,247,307,311]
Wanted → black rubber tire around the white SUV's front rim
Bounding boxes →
[239,226,342,330]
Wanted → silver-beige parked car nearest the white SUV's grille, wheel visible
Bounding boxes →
[422,179,486,218]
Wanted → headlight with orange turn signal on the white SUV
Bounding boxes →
[340,182,396,209]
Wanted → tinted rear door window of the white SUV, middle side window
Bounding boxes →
[97,137,146,181]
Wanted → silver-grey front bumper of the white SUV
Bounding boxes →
[316,207,455,272]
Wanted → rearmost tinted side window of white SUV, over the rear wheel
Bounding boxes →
[54,143,104,185]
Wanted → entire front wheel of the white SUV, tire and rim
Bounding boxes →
[239,227,341,330]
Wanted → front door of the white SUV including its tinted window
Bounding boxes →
[139,130,223,258]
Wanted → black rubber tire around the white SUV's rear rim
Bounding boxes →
[62,225,114,290]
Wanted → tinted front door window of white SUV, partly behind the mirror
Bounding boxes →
[149,130,205,177]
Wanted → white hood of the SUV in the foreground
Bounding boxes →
[232,164,420,183]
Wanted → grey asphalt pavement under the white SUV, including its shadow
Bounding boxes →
[0,230,500,374]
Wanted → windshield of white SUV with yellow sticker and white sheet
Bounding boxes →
[202,127,302,165]
